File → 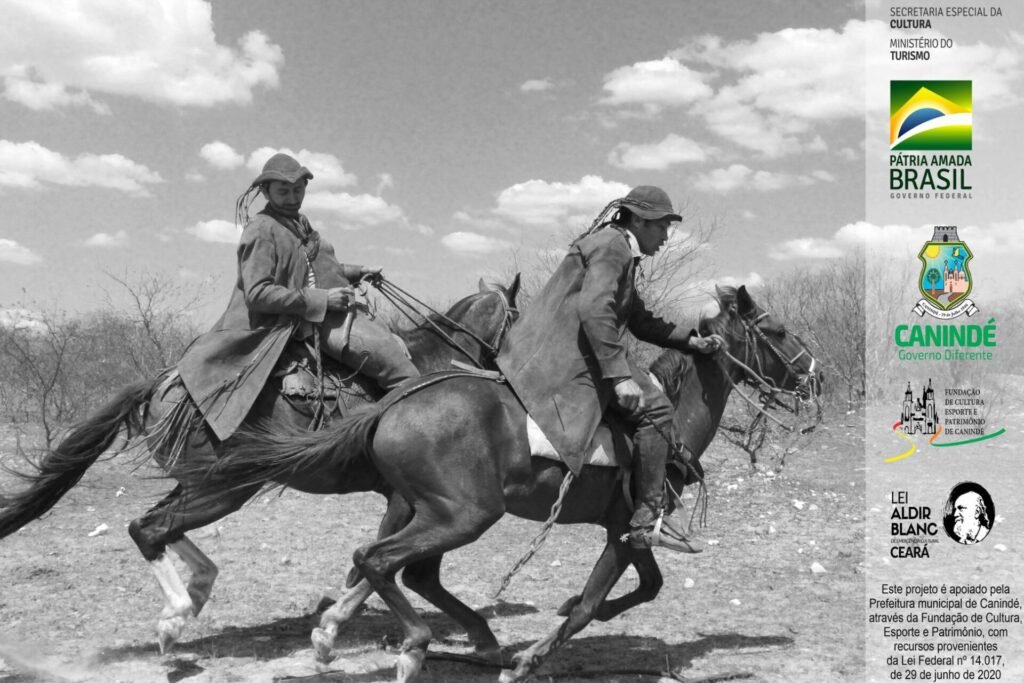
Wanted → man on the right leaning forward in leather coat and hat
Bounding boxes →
[498,185,724,552]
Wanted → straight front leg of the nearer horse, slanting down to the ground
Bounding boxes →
[499,533,633,683]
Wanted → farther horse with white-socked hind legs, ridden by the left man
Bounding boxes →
[0,274,519,653]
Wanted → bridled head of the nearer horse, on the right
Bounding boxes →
[700,287,822,402]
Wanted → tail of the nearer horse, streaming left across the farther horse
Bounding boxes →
[192,403,384,494]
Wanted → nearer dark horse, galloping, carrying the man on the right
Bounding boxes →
[190,287,822,682]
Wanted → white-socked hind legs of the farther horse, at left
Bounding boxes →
[128,484,259,652]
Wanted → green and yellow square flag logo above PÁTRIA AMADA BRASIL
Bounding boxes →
[889,81,973,152]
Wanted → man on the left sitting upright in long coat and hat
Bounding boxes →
[177,154,420,440]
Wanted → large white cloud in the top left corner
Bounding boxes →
[0,0,284,112]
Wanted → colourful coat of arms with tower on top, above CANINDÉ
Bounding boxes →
[913,225,978,321]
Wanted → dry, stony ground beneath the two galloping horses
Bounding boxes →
[0,415,865,683]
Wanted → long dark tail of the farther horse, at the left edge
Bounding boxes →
[0,380,154,539]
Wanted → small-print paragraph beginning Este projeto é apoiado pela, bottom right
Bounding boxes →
[867,583,1021,681]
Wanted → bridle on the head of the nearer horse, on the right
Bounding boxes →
[722,311,822,434]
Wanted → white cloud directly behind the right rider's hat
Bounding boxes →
[493,175,630,227]
